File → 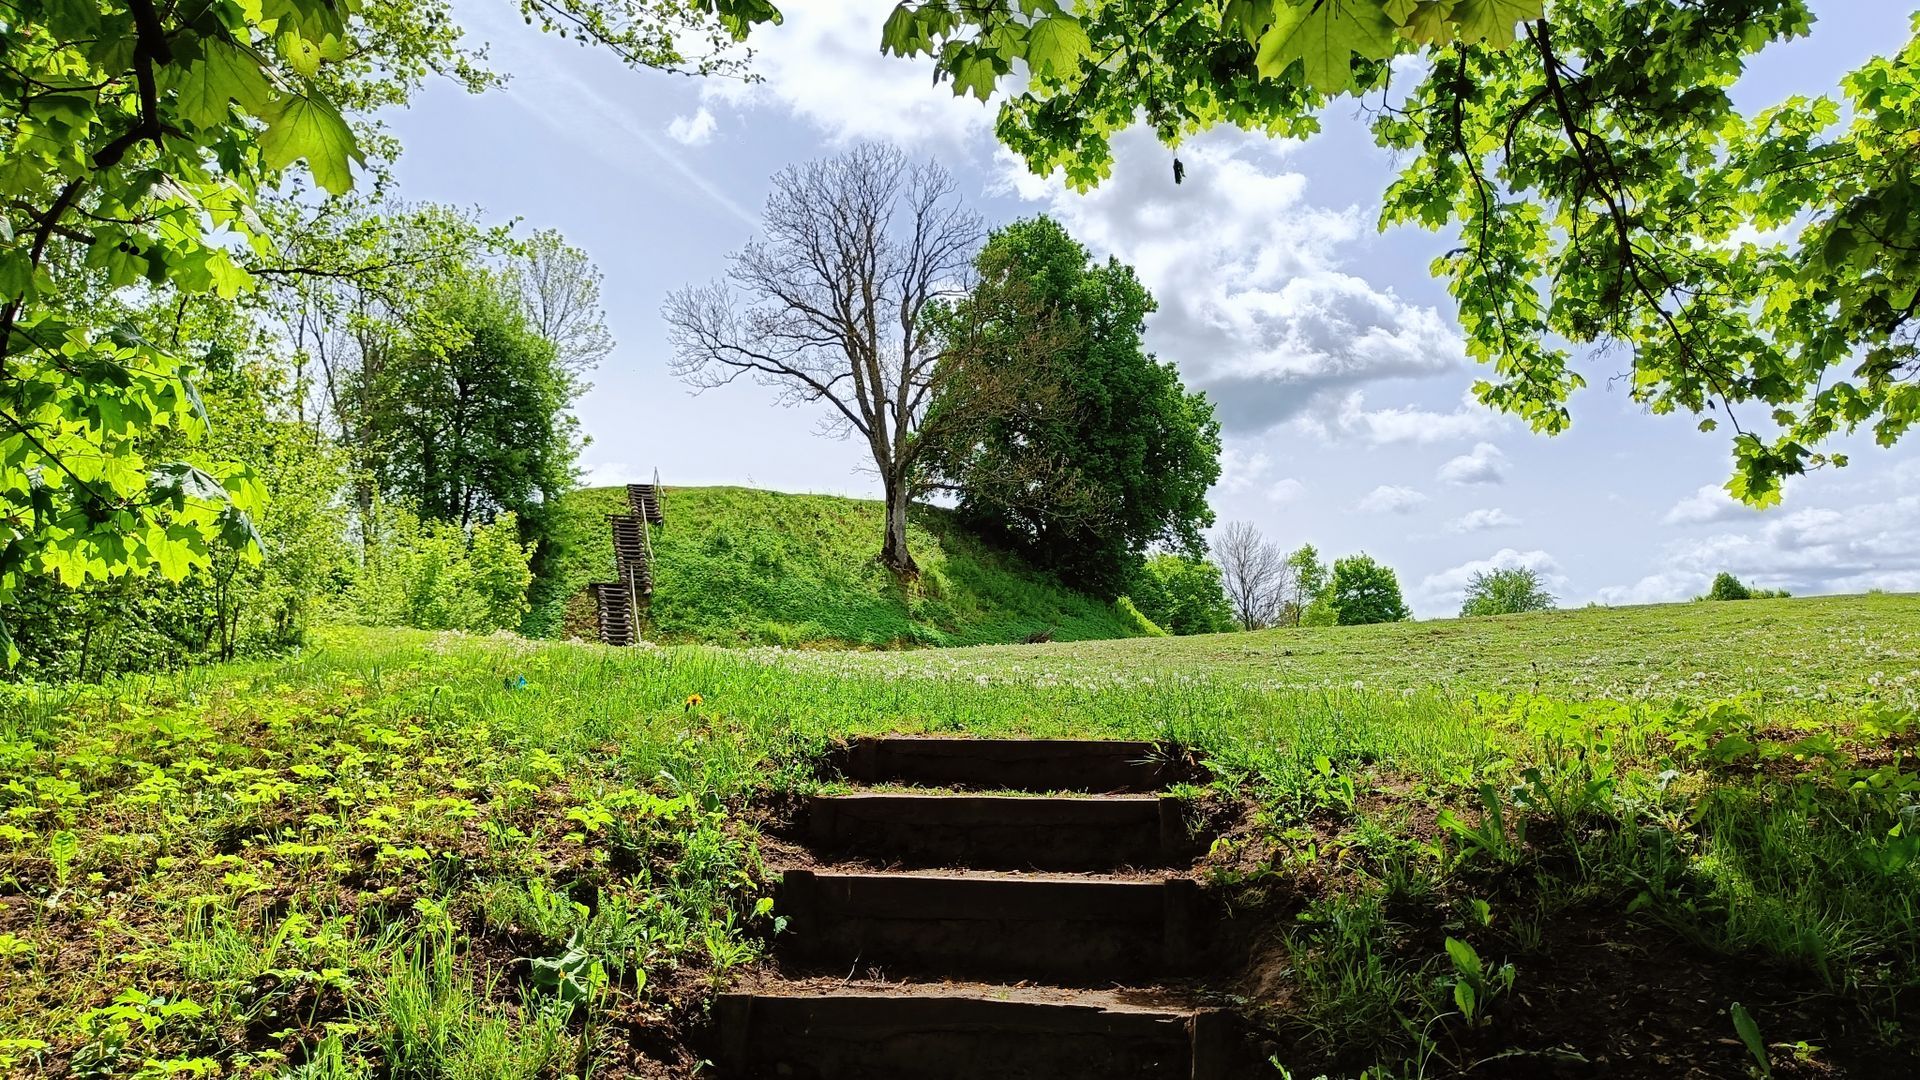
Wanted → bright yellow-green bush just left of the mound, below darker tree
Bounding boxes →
[351,502,534,632]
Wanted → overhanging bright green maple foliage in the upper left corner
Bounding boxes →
[0,0,778,663]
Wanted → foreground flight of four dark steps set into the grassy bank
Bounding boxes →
[716,738,1235,1080]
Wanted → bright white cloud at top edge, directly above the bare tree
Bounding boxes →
[701,0,995,146]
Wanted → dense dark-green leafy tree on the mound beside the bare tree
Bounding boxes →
[925,217,1219,591]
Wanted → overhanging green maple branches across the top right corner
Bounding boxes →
[881,0,1920,505]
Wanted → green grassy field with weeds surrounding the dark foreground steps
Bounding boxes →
[0,591,1920,1080]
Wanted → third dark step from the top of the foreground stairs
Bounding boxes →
[776,871,1204,986]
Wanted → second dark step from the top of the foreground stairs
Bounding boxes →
[806,792,1198,871]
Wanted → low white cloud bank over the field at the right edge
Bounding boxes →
[1599,496,1920,603]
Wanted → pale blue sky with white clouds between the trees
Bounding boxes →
[386,0,1920,617]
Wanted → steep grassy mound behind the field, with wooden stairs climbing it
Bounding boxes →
[537,488,1129,646]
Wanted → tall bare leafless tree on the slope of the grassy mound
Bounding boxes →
[664,144,981,575]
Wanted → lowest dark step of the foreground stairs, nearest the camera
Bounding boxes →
[714,986,1231,1080]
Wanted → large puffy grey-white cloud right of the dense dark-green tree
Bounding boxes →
[1000,129,1465,430]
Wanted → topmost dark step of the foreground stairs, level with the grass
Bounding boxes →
[831,736,1206,792]
